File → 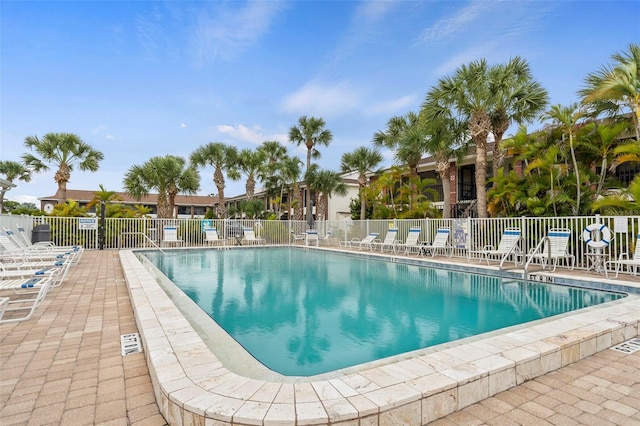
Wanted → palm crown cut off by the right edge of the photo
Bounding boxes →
[579,43,640,141]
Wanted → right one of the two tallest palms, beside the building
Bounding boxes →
[490,56,549,175]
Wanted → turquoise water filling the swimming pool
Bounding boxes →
[145,247,624,376]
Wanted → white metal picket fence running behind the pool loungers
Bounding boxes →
[0,215,640,269]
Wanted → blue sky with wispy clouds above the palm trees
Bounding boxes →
[0,0,640,206]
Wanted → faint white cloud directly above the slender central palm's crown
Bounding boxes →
[282,82,361,117]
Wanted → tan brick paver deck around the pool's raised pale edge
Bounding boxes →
[0,251,640,426]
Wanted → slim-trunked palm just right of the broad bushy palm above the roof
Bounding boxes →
[191,142,240,218]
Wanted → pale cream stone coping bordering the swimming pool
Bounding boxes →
[120,248,640,425]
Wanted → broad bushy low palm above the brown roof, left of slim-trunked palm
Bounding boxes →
[124,155,200,218]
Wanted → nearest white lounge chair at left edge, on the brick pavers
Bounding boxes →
[0,277,51,324]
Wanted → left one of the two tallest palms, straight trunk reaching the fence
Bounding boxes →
[423,59,495,218]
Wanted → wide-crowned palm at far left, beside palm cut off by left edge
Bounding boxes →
[22,133,104,203]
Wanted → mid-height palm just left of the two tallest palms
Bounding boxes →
[373,112,427,205]
